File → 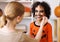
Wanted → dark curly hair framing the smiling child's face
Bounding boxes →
[32,2,51,19]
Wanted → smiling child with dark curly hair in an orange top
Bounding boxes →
[30,2,52,42]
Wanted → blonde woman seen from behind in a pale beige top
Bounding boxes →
[0,2,46,42]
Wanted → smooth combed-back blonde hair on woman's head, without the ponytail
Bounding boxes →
[4,2,24,20]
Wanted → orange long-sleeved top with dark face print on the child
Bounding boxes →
[30,22,52,42]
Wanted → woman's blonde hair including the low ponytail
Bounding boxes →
[0,2,24,28]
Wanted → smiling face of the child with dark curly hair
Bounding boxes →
[35,5,45,21]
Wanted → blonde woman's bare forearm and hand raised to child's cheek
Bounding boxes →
[35,16,48,41]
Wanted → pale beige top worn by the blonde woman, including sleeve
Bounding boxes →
[0,26,37,42]
